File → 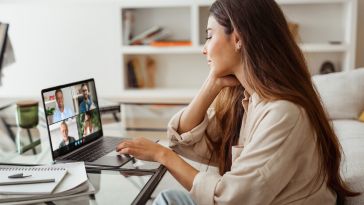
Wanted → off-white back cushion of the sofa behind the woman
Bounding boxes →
[312,68,364,120]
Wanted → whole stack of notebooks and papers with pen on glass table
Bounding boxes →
[0,162,95,204]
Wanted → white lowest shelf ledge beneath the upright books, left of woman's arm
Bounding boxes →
[113,88,198,104]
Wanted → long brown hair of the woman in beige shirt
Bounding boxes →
[206,0,359,202]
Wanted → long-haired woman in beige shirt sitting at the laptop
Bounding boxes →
[117,0,358,204]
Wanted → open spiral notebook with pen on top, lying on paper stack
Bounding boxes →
[0,165,67,194]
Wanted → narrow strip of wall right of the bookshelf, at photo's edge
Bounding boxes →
[356,0,364,67]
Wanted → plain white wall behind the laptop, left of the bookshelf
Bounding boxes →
[0,0,122,98]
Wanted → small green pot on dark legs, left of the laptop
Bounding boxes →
[16,100,39,128]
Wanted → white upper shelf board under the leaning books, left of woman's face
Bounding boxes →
[121,46,202,54]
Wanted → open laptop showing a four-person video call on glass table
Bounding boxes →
[42,79,131,167]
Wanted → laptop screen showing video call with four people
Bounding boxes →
[42,79,103,160]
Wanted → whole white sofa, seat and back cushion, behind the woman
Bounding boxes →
[313,68,364,205]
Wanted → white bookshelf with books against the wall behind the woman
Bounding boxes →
[118,0,357,103]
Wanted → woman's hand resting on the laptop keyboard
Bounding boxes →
[116,137,171,162]
